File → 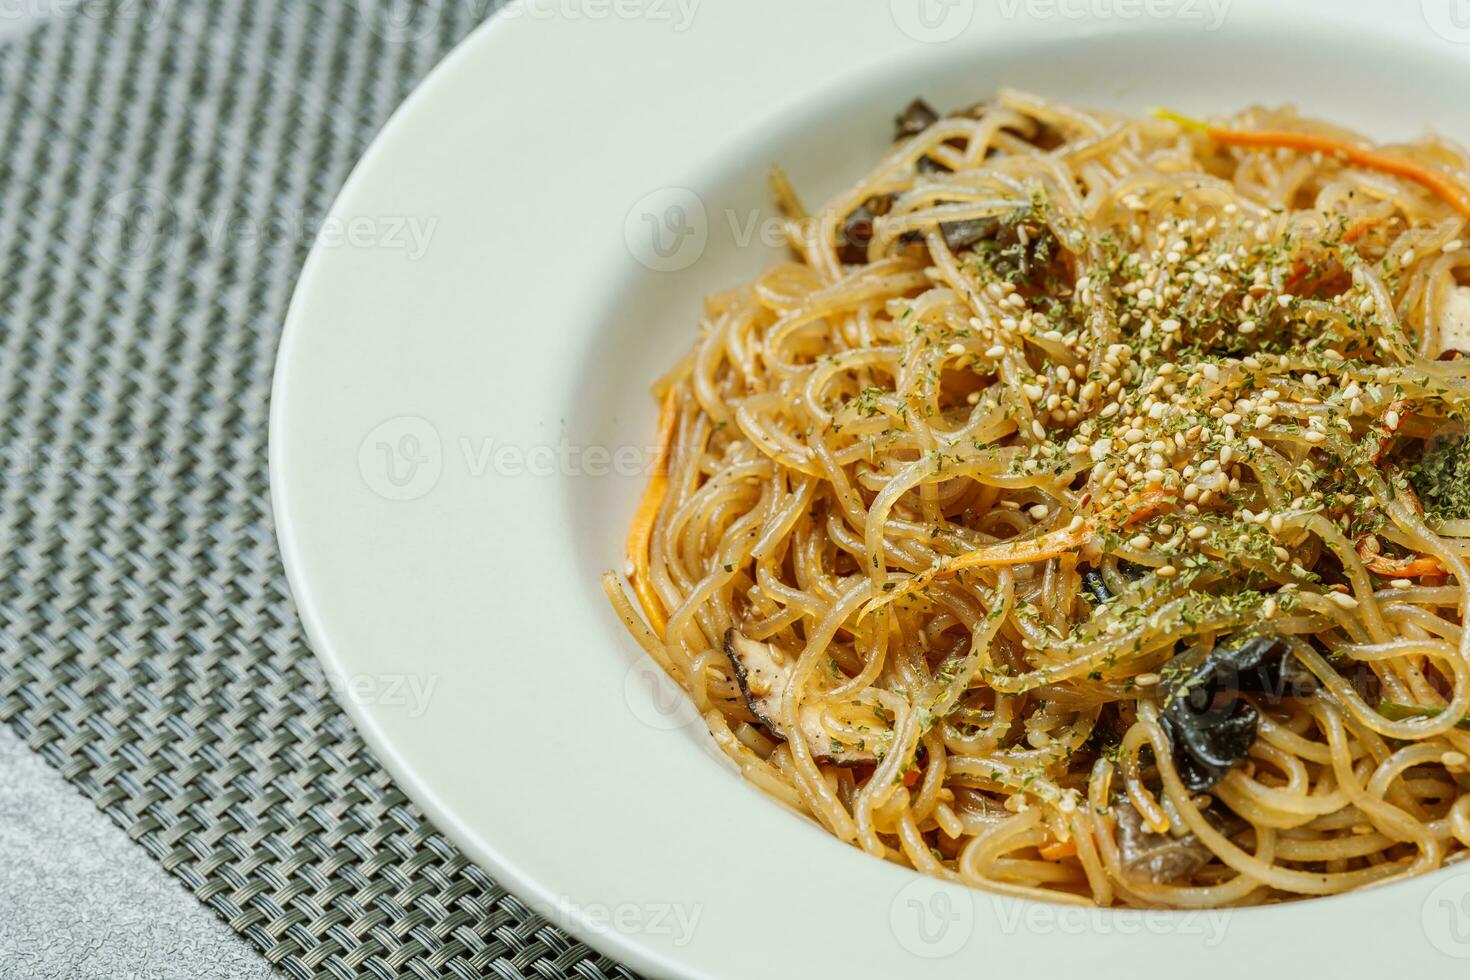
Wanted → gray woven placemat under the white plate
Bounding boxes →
[0,0,631,980]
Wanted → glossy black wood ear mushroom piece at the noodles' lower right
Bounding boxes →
[1160,635,1316,792]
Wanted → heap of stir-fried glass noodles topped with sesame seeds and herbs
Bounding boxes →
[604,91,1470,907]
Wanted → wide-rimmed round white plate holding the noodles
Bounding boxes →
[270,0,1470,979]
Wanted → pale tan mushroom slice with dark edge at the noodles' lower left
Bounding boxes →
[725,629,892,765]
